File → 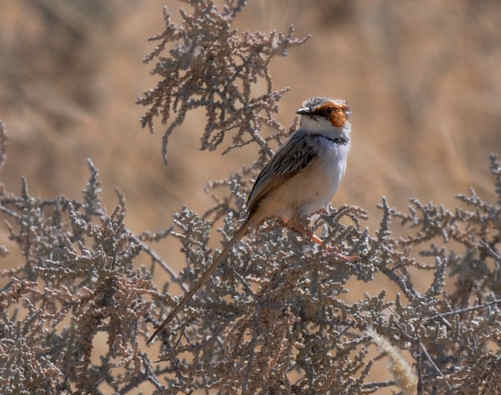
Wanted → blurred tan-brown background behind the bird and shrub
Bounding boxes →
[0,0,501,392]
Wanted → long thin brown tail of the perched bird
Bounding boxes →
[146,221,249,344]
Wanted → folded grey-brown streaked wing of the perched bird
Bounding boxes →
[247,131,318,216]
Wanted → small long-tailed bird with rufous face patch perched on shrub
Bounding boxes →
[147,97,357,344]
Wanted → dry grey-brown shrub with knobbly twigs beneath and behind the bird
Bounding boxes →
[0,0,501,394]
